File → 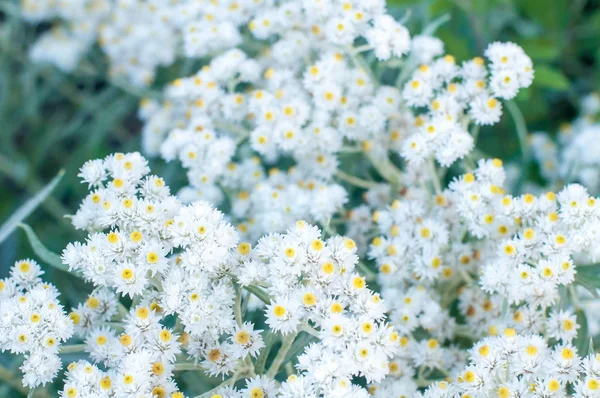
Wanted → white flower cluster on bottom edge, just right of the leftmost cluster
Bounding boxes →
[61,300,181,397]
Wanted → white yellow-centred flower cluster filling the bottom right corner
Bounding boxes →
[434,326,600,398]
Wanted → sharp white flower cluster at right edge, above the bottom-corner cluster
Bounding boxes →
[454,166,600,309]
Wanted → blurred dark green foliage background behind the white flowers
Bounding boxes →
[0,0,600,396]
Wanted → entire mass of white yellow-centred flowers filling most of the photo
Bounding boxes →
[7,0,600,398]
